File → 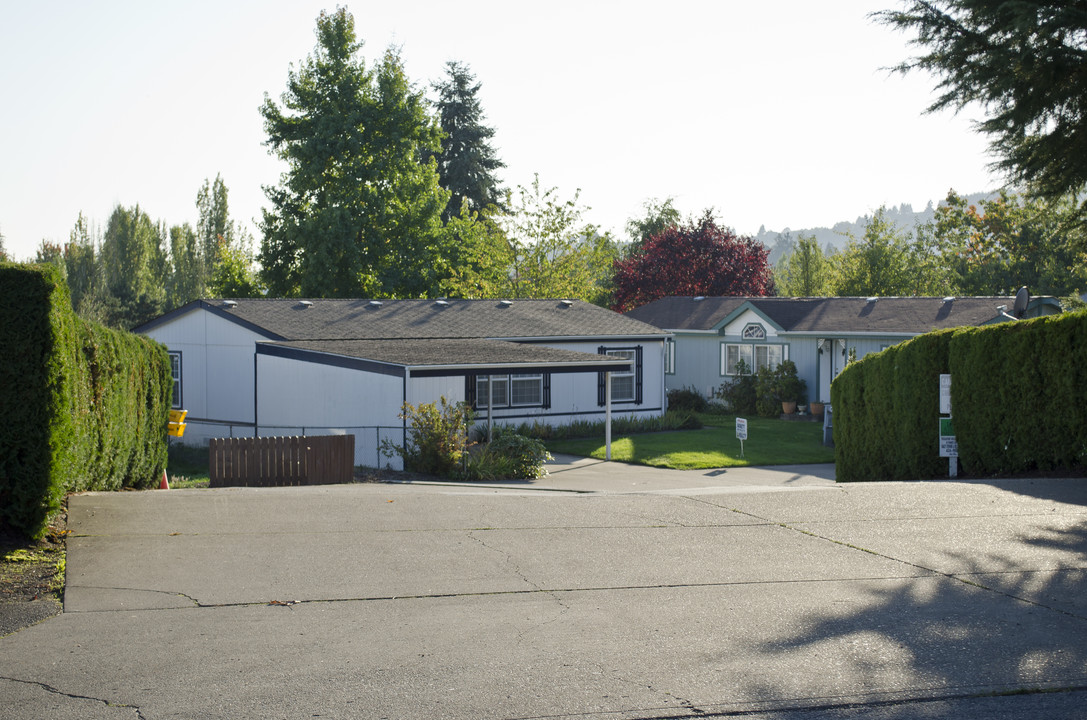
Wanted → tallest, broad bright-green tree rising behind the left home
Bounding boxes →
[260,9,449,297]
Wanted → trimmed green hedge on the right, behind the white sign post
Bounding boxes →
[830,311,1087,482]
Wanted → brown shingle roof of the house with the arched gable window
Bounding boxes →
[626,296,1052,334]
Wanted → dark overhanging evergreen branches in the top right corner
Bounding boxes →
[874,0,1087,205]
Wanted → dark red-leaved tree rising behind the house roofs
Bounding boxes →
[612,210,774,312]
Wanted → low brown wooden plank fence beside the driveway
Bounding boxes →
[208,435,354,487]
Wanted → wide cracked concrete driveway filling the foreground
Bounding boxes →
[0,458,1087,720]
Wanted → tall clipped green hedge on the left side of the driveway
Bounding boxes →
[0,264,173,537]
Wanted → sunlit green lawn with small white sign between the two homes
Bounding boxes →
[547,415,834,470]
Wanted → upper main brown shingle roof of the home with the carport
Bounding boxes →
[136,298,664,340]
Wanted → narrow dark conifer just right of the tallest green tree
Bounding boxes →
[434,62,505,222]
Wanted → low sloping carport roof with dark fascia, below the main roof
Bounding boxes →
[257,339,630,376]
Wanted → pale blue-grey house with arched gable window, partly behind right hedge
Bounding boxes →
[626,296,1061,402]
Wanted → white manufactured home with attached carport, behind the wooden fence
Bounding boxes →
[136,299,667,468]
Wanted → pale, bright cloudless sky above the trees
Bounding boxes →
[0,0,1001,259]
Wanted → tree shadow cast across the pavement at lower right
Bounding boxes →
[747,516,1087,718]
